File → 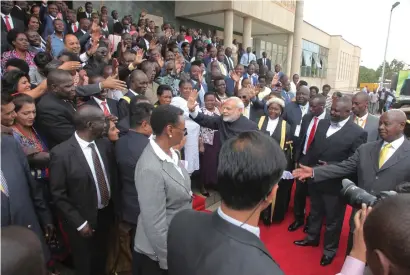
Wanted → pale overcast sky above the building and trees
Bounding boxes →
[303,0,410,69]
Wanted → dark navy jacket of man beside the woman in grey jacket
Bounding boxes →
[115,131,149,225]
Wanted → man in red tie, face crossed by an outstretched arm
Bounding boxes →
[86,76,119,118]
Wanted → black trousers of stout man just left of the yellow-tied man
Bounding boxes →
[306,186,346,257]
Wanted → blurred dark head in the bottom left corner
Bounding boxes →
[1,226,46,275]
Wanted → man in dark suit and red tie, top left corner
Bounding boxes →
[0,0,24,52]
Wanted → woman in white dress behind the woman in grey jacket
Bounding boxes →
[171,80,200,174]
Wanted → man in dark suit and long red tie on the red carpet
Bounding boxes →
[288,95,330,233]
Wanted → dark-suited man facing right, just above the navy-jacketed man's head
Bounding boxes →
[118,70,149,119]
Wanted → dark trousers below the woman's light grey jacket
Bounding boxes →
[132,250,168,275]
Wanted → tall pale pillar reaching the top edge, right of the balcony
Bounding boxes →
[290,1,304,75]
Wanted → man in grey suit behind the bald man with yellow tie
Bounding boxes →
[352,92,380,142]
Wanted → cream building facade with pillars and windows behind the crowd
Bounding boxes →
[81,0,361,91]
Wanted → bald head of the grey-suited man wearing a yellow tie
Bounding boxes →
[379,109,407,142]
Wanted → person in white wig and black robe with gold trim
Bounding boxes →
[258,97,293,225]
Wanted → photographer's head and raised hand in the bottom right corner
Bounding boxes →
[338,194,410,275]
